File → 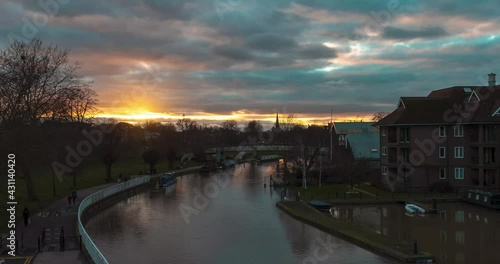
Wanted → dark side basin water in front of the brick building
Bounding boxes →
[332,203,500,263]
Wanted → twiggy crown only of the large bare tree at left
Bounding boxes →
[0,39,97,126]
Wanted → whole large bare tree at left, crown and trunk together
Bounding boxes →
[0,39,97,200]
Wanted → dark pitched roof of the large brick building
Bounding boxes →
[374,85,500,126]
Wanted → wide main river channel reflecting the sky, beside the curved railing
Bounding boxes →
[86,164,397,264]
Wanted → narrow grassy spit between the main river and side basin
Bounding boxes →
[276,201,435,263]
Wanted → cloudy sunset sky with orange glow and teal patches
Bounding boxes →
[0,0,500,128]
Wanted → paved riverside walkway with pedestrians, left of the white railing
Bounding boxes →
[0,166,201,264]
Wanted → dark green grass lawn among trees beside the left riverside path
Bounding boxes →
[0,158,185,233]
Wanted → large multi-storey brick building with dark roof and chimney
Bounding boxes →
[374,73,500,191]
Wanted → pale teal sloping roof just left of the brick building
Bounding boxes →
[347,133,380,159]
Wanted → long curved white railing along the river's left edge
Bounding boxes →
[77,176,150,264]
